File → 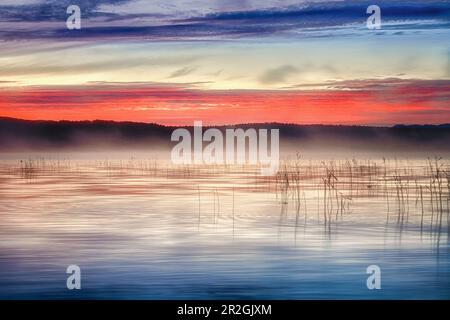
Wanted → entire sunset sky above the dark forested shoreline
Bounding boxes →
[0,0,450,126]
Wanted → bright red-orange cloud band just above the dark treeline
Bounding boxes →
[0,79,450,125]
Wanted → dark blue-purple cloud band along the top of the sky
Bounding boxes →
[0,0,450,41]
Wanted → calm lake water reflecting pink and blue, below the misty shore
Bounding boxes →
[0,160,450,299]
